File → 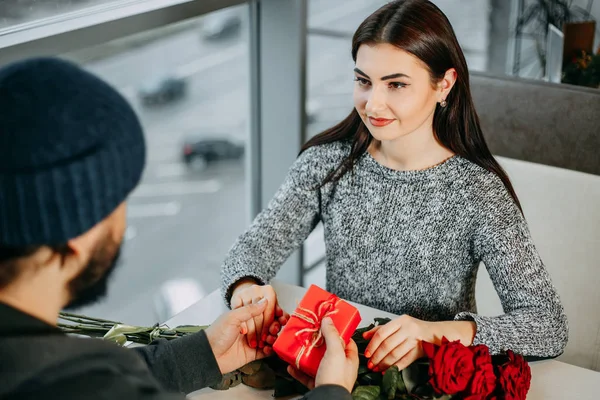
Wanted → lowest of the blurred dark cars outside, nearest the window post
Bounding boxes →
[182,137,244,171]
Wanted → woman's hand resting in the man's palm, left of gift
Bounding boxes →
[231,281,289,349]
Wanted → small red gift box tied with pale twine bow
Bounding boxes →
[273,285,361,377]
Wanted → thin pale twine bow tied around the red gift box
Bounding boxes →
[292,294,340,369]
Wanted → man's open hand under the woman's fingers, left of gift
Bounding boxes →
[206,298,275,374]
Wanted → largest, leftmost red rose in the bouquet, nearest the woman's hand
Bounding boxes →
[423,337,475,395]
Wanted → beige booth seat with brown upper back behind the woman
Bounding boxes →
[471,74,600,370]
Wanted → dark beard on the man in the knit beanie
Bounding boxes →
[65,238,121,310]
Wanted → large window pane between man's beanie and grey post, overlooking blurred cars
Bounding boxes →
[64,5,250,326]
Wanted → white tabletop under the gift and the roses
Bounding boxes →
[166,281,600,400]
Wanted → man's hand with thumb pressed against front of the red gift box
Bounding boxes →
[288,318,358,392]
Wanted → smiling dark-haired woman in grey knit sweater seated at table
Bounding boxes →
[223,0,568,371]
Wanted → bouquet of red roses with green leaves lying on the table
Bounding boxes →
[338,319,531,400]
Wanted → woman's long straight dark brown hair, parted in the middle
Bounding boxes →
[301,0,521,208]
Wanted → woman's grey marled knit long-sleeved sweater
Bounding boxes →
[222,142,568,356]
